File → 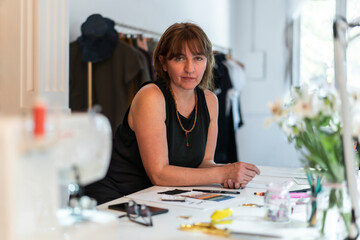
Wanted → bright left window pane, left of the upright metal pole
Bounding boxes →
[299,0,336,85]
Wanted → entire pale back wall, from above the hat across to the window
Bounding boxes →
[69,0,300,167]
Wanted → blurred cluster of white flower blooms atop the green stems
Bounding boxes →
[266,85,360,138]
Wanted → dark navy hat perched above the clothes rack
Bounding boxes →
[77,14,119,62]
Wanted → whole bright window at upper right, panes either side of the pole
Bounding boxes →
[293,0,360,88]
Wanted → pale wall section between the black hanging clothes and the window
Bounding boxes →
[232,0,301,167]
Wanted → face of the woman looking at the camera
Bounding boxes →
[161,45,207,90]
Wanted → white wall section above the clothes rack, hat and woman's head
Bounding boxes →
[70,0,231,46]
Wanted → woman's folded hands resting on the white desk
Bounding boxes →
[223,162,260,189]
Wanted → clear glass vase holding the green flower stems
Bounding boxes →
[316,181,351,240]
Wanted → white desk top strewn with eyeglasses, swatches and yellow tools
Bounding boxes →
[98,168,318,240]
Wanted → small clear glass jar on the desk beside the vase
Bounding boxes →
[265,182,293,222]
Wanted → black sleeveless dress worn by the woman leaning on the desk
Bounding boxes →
[85,81,210,204]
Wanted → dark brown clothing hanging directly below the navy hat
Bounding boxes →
[69,38,150,133]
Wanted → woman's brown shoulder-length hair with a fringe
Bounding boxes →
[153,23,214,89]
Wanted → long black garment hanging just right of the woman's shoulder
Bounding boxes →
[214,53,238,163]
